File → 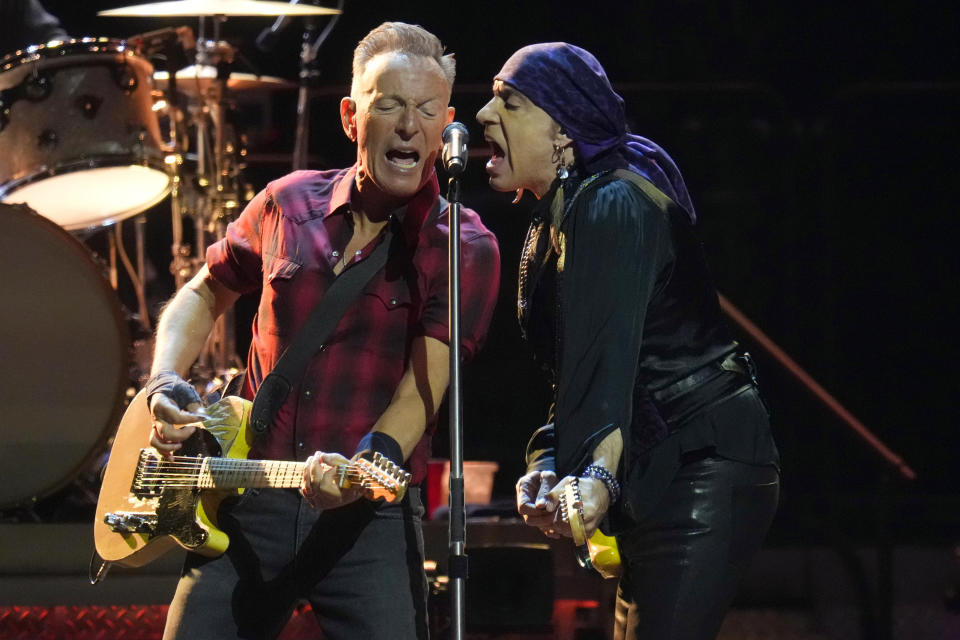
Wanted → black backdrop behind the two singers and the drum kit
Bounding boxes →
[31,0,960,542]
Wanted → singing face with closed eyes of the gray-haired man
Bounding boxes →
[340,51,453,200]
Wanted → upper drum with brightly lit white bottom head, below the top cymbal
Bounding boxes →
[0,38,170,230]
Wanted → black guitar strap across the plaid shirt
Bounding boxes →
[250,198,443,434]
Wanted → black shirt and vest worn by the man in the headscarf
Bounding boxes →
[519,172,777,524]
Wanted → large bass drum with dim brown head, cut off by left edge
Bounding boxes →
[0,204,130,509]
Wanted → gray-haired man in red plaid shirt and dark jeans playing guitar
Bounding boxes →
[148,23,500,640]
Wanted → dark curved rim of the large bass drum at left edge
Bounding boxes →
[0,203,132,510]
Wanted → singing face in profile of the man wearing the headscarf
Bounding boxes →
[477,80,570,198]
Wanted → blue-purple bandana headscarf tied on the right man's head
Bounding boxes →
[495,42,696,221]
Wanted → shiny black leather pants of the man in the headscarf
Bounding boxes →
[614,456,780,640]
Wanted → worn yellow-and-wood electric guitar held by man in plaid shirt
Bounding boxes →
[93,391,410,567]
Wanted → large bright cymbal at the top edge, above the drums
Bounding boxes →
[97,0,340,18]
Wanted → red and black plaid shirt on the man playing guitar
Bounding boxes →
[207,166,500,483]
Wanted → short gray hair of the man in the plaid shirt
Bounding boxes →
[350,22,457,96]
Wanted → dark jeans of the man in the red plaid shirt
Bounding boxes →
[164,487,427,640]
